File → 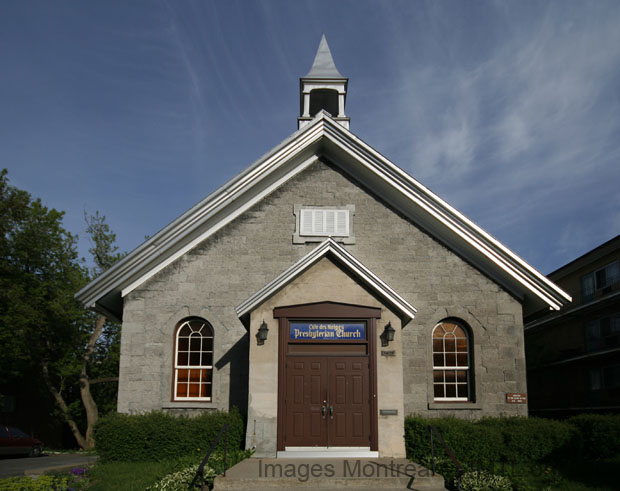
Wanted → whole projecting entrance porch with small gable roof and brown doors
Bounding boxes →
[238,239,415,458]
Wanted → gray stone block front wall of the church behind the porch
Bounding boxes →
[118,162,527,418]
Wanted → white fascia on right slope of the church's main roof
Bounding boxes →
[325,119,571,310]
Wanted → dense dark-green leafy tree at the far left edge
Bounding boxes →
[0,170,87,442]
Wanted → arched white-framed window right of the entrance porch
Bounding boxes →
[433,321,472,401]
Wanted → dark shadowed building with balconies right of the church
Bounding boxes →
[525,235,620,416]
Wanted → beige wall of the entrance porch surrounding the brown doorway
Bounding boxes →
[246,258,405,458]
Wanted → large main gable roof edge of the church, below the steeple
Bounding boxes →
[76,111,571,319]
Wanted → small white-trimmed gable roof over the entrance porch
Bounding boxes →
[235,237,417,326]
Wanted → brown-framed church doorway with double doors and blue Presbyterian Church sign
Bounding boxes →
[274,302,381,457]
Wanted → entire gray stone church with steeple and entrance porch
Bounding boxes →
[77,38,570,457]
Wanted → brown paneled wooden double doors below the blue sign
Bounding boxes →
[284,355,371,447]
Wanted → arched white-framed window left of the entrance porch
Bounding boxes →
[174,318,213,401]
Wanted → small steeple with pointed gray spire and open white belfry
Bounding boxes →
[297,34,349,129]
